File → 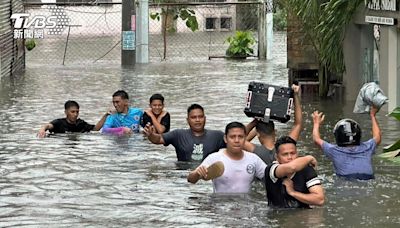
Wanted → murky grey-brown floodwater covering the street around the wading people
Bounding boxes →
[0,31,400,227]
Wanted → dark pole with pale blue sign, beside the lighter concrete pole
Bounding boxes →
[121,0,136,66]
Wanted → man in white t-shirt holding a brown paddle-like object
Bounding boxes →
[187,122,266,193]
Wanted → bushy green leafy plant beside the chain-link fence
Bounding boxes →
[225,31,256,59]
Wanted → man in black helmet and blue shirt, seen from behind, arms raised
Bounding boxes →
[312,106,381,180]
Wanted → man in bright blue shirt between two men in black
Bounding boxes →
[102,90,143,135]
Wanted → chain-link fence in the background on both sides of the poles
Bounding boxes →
[25,2,261,65]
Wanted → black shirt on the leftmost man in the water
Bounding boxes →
[49,118,94,133]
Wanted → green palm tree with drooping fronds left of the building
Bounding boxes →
[280,0,364,96]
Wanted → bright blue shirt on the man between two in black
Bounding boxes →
[102,108,143,133]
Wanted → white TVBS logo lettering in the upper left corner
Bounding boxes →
[11,13,57,29]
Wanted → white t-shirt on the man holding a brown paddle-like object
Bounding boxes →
[201,149,267,193]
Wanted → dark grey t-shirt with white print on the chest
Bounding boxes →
[162,129,226,161]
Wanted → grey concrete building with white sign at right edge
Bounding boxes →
[343,0,400,111]
